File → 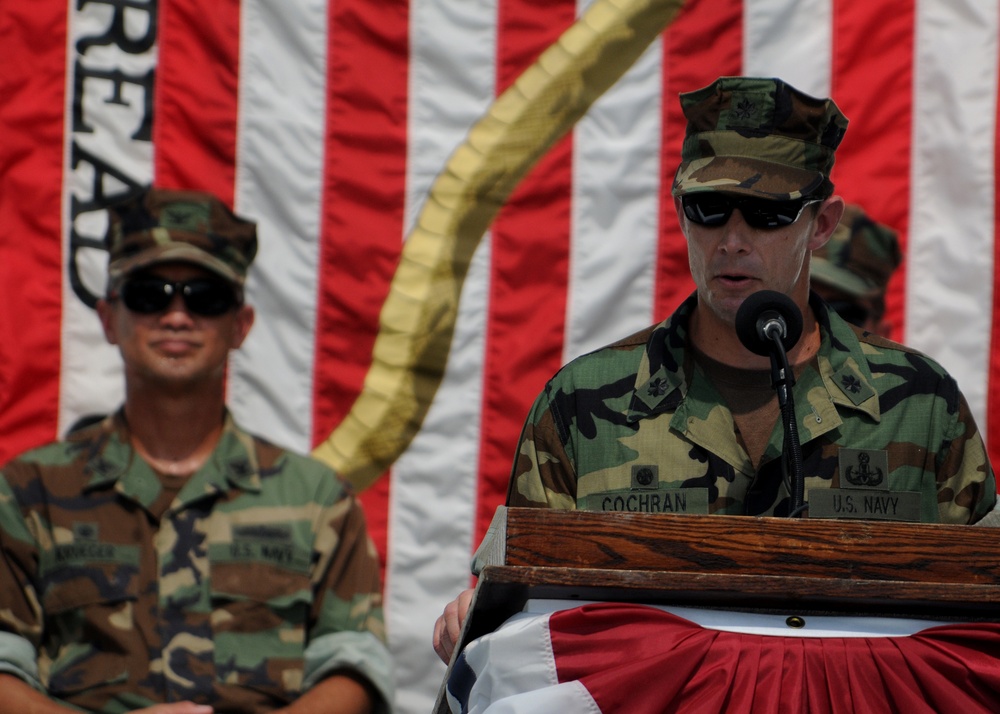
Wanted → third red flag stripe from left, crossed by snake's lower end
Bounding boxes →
[320,0,409,563]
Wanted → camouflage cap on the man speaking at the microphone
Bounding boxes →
[673,77,847,201]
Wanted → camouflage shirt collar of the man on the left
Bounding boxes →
[82,407,260,505]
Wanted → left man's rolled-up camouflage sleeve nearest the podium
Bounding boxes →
[303,495,394,713]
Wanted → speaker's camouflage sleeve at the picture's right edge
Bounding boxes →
[937,379,997,524]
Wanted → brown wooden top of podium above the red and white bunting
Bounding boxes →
[435,507,1000,714]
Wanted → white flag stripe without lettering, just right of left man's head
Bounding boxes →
[229,0,327,452]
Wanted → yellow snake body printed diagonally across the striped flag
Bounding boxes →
[313,0,684,491]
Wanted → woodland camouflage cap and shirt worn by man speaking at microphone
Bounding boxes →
[507,77,996,523]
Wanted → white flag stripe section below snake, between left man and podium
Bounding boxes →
[385,245,490,714]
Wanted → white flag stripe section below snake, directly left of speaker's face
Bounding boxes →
[563,41,669,362]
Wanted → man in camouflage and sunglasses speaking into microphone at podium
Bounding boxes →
[434,77,996,661]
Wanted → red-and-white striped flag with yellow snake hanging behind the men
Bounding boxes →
[0,0,1000,713]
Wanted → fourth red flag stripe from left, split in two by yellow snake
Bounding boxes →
[475,0,576,542]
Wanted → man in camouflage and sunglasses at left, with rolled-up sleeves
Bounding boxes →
[0,189,392,714]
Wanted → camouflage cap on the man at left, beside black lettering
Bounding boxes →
[105,187,257,289]
